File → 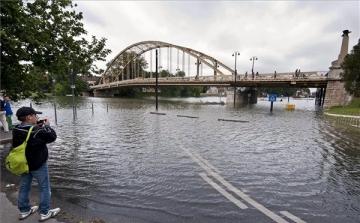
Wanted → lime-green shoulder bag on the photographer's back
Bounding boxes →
[5,126,34,175]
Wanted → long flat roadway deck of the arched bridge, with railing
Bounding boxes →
[90,72,339,91]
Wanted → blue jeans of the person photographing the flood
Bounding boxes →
[18,163,51,214]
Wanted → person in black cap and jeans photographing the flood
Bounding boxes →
[12,107,60,222]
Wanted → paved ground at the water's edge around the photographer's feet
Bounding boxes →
[0,141,144,223]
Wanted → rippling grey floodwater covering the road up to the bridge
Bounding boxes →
[2,97,360,223]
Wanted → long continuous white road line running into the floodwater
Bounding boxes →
[176,138,289,223]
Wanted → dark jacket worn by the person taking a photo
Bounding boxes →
[12,125,57,171]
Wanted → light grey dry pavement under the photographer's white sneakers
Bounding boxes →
[0,192,63,223]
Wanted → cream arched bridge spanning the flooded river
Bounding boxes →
[90,41,339,92]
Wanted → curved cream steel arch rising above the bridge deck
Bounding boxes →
[100,41,234,84]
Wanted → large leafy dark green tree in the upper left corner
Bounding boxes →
[0,0,111,100]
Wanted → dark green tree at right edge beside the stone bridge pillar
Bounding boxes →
[340,39,360,97]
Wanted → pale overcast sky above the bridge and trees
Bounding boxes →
[74,0,360,75]
